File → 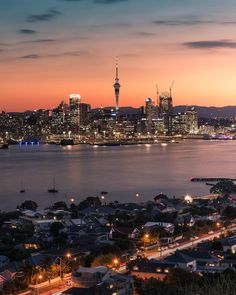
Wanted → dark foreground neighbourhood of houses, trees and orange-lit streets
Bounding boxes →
[0,181,236,295]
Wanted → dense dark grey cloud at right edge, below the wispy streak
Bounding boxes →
[182,40,236,49]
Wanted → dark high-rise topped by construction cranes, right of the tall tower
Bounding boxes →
[159,91,173,135]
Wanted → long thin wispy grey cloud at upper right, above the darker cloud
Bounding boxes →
[153,18,236,26]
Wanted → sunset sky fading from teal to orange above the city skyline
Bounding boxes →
[0,0,236,111]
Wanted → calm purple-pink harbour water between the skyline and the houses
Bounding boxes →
[0,140,236,210]
